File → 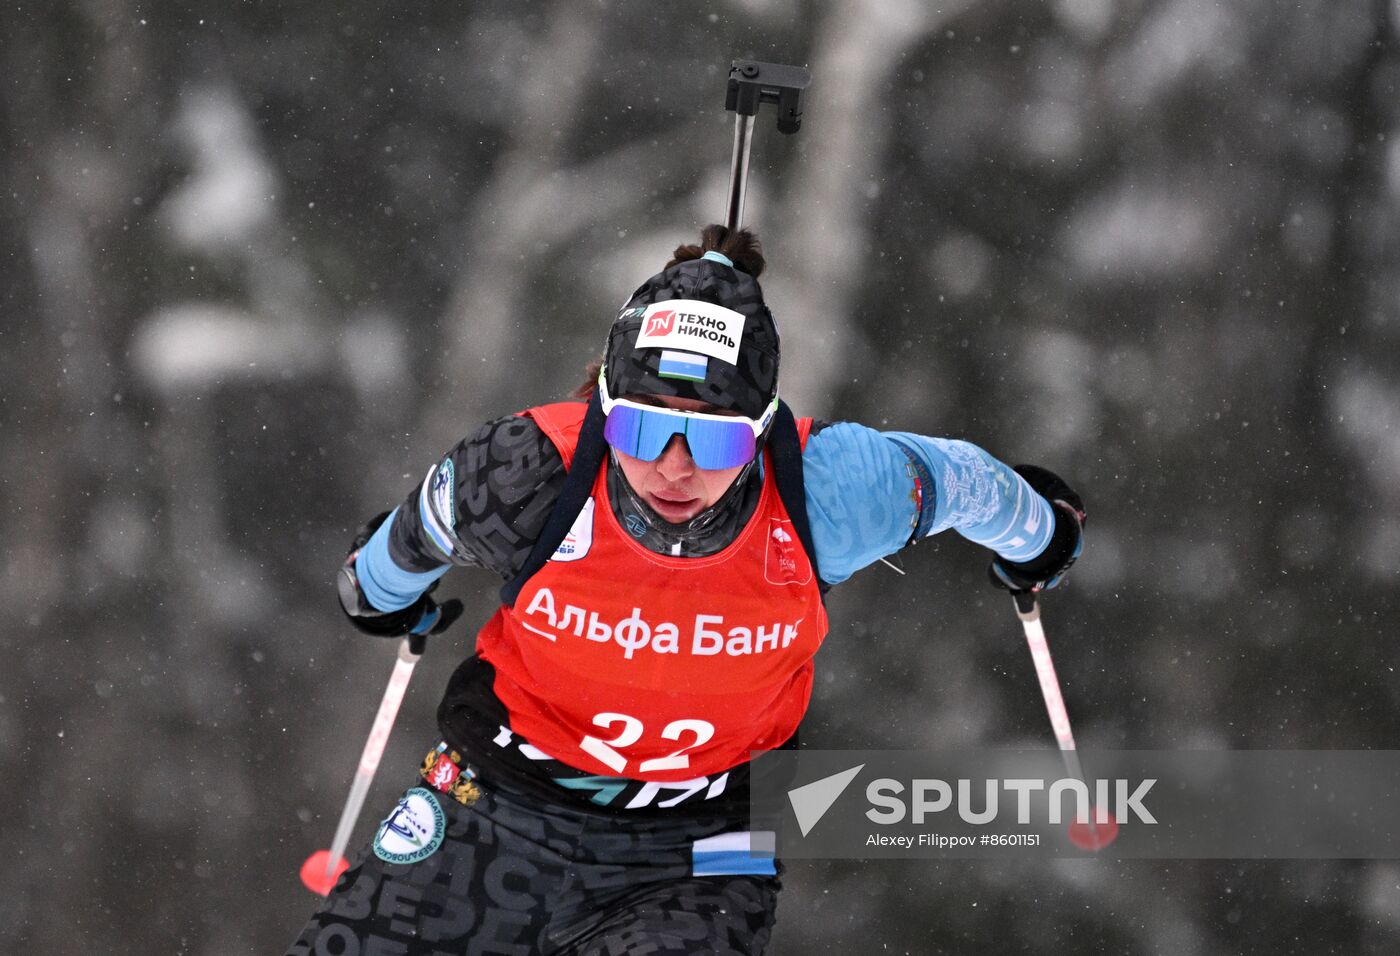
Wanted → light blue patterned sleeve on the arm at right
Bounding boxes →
[802,421,1054,584]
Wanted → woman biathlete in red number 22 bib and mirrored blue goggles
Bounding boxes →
[291,225,1084,956]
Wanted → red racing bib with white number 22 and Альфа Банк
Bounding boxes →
[477,403,827,782]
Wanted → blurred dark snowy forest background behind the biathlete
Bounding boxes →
[0,0,1400,956]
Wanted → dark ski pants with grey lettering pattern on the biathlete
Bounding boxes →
[288,781,780,956]
